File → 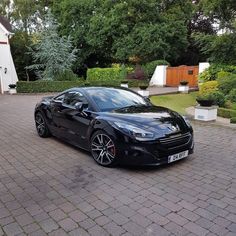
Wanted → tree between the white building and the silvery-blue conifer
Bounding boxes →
[0,0,53,80]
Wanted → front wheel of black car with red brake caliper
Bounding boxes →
[90,130,117,167]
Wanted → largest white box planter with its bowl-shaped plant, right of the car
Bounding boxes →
[195,93,218,121]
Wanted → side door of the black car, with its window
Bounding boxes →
[60,91,92,148]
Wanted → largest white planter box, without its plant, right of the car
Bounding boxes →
[194,105,218,121]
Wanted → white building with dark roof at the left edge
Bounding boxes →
[0,16,18,94]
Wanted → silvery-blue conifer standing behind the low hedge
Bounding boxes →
[27,12,77,80]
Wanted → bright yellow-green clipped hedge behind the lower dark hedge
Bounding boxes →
[87,67,133,82]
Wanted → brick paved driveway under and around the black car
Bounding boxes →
[0,95,236,236]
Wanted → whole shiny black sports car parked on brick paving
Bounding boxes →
[35,87,194,166]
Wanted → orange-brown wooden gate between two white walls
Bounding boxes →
[166,66,199,87]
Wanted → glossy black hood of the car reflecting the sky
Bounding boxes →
[100,106,189,138]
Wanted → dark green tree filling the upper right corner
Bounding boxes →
[195,0,236,64]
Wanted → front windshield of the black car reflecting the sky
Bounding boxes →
[86,88,150,111]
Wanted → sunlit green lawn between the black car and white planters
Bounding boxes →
[151,92,198,114]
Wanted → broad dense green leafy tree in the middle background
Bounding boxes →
[54,0,194,66]
